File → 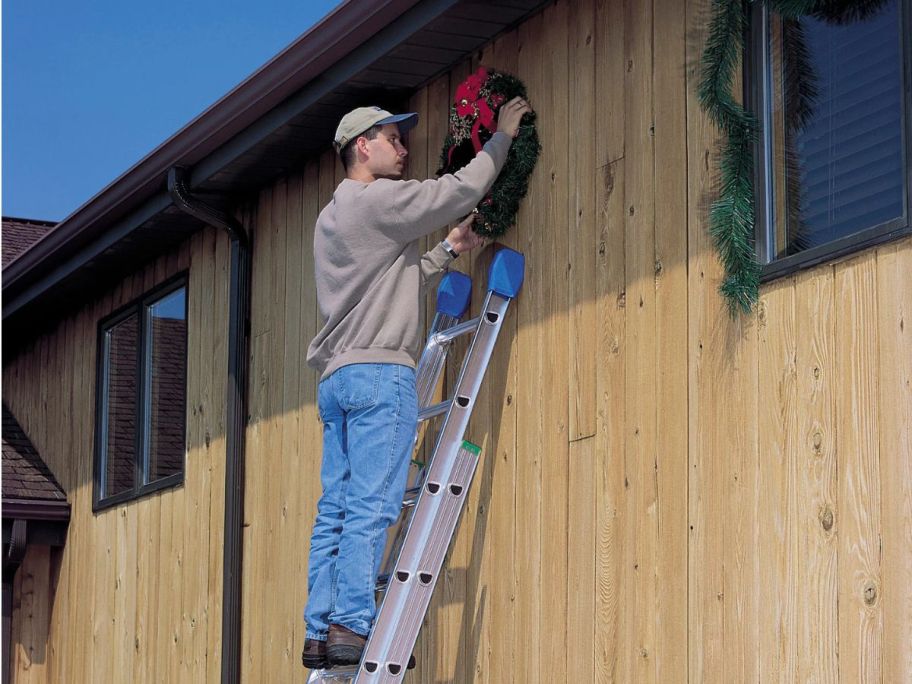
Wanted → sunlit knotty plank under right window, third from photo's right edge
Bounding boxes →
[795,267,839,682]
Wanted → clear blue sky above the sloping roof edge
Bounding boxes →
[2,0,340,221]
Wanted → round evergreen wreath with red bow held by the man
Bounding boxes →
[437,67,541,237]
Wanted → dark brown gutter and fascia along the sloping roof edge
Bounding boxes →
[3,0,422,308]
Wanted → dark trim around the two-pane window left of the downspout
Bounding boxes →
[92,270,190,513]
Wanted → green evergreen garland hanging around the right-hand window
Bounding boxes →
[697,0,890,316]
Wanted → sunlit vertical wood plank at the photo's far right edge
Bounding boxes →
[877,240,912,682]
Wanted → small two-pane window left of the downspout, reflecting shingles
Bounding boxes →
[95,275,187,509]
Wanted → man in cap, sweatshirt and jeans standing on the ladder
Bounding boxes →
[302,98,531,668]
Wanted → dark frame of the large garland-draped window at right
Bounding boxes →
[743,0,912,283]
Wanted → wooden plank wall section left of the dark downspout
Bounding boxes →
[3,229,228,684]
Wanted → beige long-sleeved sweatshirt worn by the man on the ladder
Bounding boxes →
[307,133,512,379]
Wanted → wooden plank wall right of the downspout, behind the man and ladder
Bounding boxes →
[243,0,912,684]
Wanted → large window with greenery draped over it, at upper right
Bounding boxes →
[746,0,912,279]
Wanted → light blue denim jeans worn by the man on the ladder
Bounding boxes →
[304,363,418,641]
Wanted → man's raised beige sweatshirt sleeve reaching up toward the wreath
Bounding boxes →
[371,132,513,242]
